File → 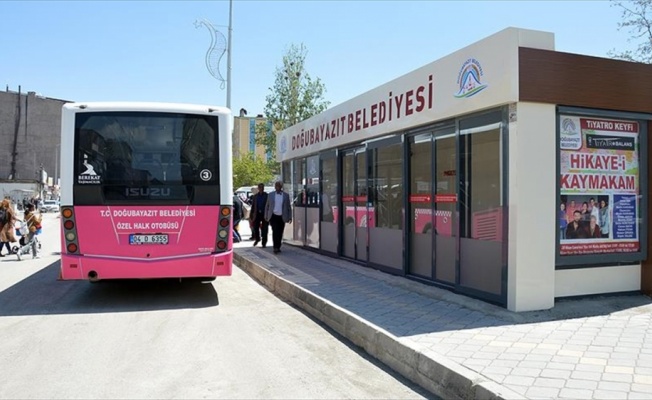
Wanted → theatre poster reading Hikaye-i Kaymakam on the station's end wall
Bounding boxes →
[557,115,641,256]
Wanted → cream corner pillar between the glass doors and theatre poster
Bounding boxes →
[507,102,557,311]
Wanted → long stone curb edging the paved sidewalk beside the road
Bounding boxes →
[233,250,523,400]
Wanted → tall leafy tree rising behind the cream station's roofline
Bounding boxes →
[256,44,330,155]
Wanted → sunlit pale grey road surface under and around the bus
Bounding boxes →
[0,214,430,399]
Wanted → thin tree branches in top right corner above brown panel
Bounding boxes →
[609,0,652,64]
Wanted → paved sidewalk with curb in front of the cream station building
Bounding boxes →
[234,238,652,399]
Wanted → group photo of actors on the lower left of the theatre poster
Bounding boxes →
[559,195,611,240]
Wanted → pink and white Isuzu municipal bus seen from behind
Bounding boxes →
[60,102,233,282]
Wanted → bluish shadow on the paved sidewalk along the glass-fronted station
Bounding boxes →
[238,246,652,336]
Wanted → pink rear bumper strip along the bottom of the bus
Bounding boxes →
[60,251,233,281]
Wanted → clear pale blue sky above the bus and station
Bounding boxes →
[0,0,635,116]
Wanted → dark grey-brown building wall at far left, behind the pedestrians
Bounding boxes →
[0,91,66,185]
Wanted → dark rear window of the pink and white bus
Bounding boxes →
[75,112,219,200]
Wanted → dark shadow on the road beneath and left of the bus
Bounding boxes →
[0,261,219,317]
